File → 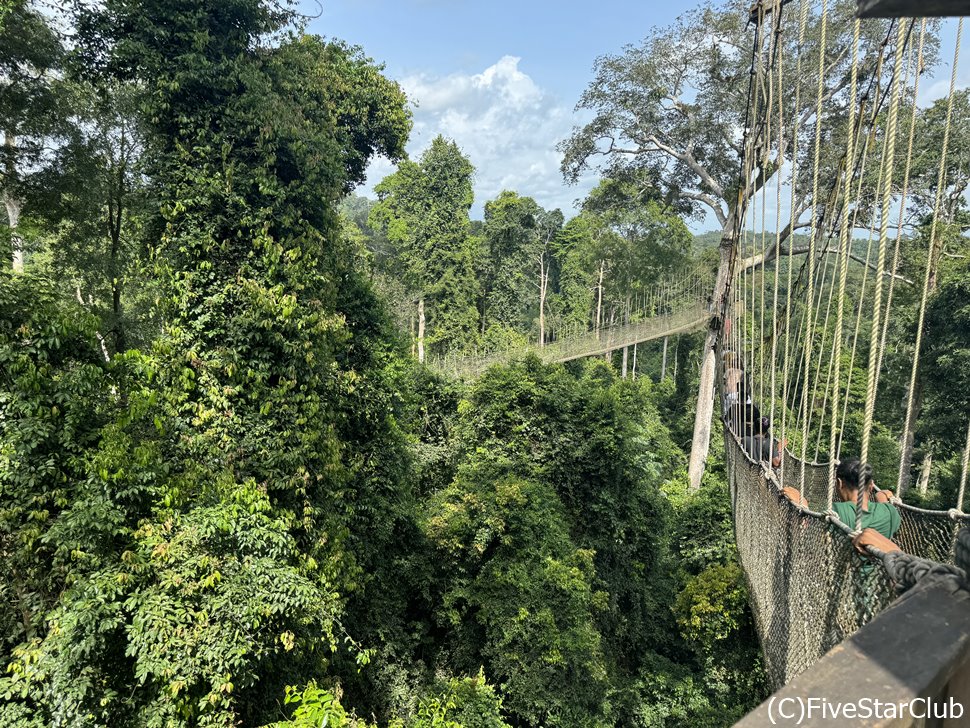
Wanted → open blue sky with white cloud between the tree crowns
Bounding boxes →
[300,0,697,218]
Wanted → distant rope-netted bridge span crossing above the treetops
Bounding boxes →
[428,271,712,378]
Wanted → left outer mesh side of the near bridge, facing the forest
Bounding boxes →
[725,431,895,686]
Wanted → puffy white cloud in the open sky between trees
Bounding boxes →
[361,56,593,217]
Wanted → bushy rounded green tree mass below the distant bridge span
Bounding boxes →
[425,359,678,725]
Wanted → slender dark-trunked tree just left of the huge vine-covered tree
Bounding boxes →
[26,83,151,351]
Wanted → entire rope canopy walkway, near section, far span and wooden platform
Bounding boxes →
[437,0,970,726]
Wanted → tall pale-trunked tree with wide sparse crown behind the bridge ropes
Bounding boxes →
[560,0,908,489]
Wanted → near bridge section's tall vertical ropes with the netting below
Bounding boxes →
[716,0,970,685]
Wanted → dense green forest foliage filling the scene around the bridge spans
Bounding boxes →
[0,0,970,728]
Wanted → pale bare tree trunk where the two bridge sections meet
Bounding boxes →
[687,225,737,491]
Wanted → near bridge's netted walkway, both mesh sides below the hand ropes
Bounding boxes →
[725,420,970,687]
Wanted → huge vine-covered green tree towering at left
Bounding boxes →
[3,0,408,725]
